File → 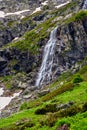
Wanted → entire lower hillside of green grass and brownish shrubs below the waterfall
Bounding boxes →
[0,66,87,130]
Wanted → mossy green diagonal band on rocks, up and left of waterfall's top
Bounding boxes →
[0,2,82,54]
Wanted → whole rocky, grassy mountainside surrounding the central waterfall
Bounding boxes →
[0,0,87,130]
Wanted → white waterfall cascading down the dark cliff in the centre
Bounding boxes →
[35,27,57,87]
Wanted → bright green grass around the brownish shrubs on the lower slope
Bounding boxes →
[0,66,87,130]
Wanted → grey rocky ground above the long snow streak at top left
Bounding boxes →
[0,0,67,13]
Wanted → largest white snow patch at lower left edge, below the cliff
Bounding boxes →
[0,91,21,111]
